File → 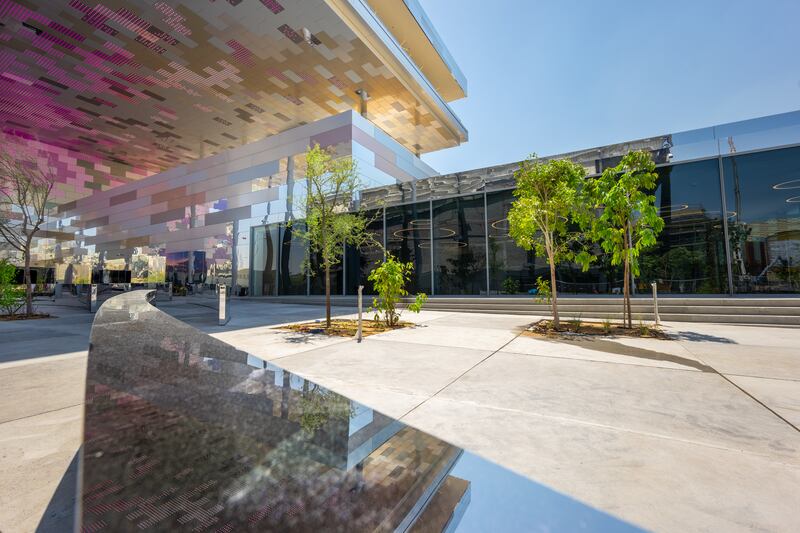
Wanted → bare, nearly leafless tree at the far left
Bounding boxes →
[0,153,55,316]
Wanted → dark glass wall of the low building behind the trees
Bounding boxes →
[247,147,800,295]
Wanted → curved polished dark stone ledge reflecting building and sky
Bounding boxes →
[79,291,636,531]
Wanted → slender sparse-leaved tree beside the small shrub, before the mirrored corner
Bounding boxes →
[299,144,370,328]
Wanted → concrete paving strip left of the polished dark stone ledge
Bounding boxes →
[0,303,93,533]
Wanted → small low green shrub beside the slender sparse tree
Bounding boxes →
[368,253,428,327]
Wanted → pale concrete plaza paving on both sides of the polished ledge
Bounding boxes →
[0,298,800,532]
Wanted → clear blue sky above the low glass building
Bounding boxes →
[419,0,800,173]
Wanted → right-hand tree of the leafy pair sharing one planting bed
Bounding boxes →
[587,150,664,328]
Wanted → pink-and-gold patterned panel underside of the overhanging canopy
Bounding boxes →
[0,0,466,172]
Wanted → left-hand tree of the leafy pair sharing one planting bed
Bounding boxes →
[508,154,586,327]
